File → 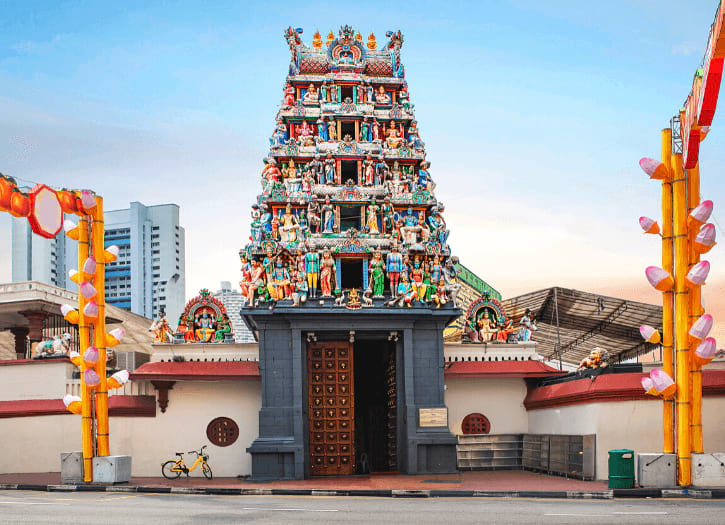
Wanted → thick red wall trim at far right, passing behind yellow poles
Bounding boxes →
[524,370,725,410]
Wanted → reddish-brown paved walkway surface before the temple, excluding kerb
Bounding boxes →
[0,470,607,492]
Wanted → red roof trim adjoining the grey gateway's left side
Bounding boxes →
[131,361,261,381]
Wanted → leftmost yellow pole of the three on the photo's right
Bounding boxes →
[662,128,675,454]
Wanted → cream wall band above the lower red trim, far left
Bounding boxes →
[0,361,68,400]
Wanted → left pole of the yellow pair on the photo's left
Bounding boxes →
[78,217,93,483]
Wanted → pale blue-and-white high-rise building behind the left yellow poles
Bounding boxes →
[12,202,186,320]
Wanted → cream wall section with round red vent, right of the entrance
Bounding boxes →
[445,377,528,434]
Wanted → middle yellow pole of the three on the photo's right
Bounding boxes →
[672,154,692,485]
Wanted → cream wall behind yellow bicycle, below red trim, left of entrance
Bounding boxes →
[0,380,261,477]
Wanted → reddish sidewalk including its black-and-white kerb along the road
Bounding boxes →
[0,470,725,499]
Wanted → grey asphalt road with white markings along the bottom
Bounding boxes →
[0,491,725,525]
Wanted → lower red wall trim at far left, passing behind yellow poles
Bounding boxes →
[0,396,156,418]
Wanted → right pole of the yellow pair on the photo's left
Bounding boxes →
[91,196,109,456]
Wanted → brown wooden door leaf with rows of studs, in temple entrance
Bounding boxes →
[307,341,355,476]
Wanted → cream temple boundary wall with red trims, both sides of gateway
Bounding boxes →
[0,345,725,479]
